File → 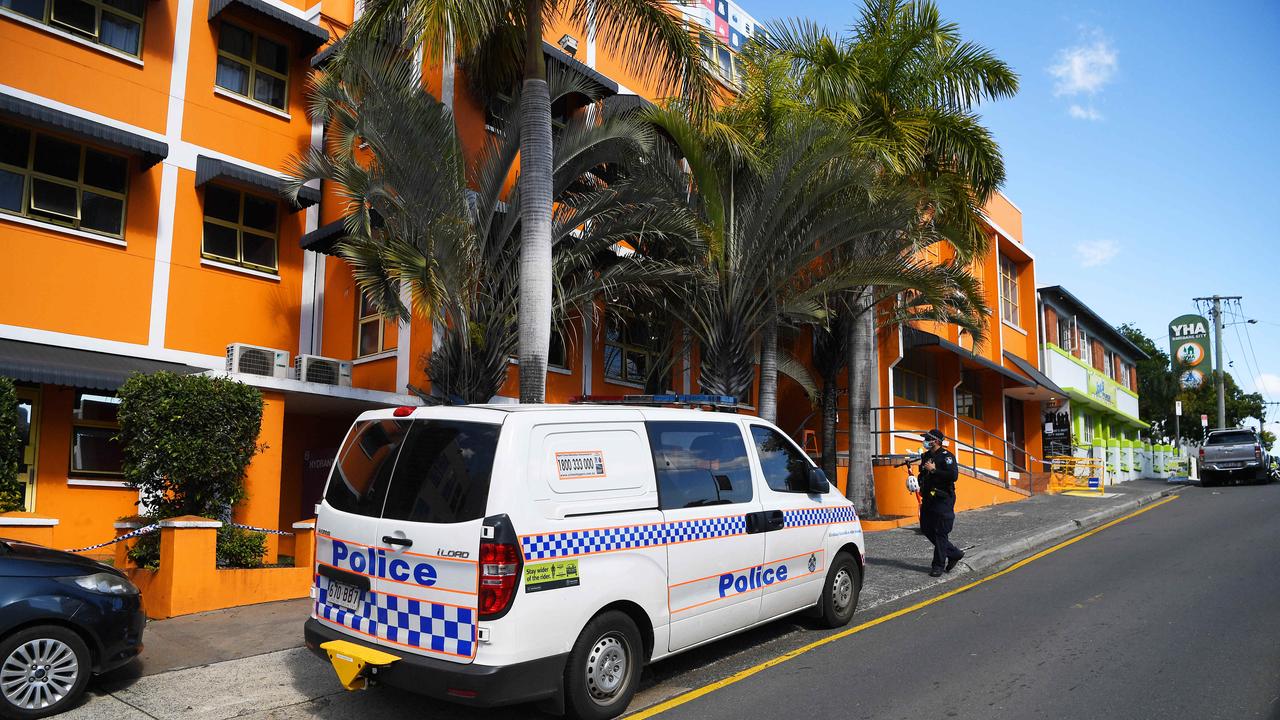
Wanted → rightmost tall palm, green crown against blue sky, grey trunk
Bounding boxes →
[769,0,1018,515]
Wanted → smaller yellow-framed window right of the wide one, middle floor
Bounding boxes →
[201,184,279,273]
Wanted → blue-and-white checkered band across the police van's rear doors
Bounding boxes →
[316,582,476,657]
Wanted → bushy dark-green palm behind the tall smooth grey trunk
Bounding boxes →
[291,45,698,404]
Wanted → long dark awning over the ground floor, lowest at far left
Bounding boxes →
[0,340,205,391]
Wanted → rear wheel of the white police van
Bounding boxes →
[564,610,644,720]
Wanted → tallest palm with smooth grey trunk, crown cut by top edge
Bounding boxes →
[339,0,717,402]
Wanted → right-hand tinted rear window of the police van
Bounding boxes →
[383,420,500,523]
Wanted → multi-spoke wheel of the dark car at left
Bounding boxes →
[0,625,93,720]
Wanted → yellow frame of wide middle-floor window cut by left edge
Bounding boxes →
[0,122,133,241]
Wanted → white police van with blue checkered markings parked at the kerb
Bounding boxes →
[305,397,864,719]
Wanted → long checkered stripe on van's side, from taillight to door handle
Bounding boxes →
[520,515,746,560]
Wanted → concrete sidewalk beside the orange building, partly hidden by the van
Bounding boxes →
[65,480,1180,720]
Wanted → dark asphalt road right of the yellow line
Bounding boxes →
[659,484,1280,720]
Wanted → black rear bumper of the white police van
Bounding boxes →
[303,618,568,707]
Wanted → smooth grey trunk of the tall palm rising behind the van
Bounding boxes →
[518,0,552,402]
